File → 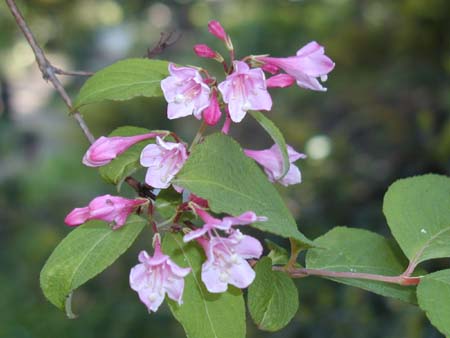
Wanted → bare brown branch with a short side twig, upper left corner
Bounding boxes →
[6,0,95,143]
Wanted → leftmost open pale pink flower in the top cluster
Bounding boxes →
[161,63,210,120]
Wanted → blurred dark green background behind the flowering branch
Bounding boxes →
[0,0,450,338]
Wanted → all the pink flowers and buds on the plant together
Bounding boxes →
[65,21,334,312]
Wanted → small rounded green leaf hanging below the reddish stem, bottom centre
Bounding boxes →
[247,257,298,331]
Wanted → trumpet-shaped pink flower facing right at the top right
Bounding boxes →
[257,41,334,91]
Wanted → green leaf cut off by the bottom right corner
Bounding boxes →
[417,270,450,337]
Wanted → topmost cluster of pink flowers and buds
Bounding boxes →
[161,21,334,125]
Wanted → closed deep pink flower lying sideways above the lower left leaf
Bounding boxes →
[64,195,147,229]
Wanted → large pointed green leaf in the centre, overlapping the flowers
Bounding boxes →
[173,134,312,246]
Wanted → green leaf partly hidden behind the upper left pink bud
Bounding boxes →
[99,126,165,190]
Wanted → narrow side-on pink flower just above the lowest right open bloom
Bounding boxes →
[183,208,267,242]
